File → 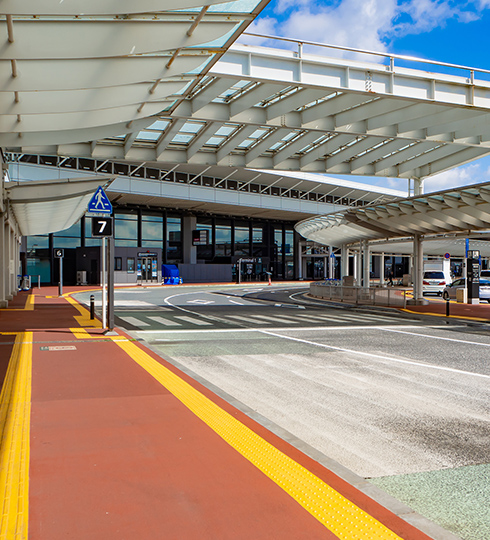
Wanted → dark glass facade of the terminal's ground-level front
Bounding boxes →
[26,208,295,283]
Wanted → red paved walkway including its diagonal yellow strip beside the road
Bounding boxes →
[0,288,460,540]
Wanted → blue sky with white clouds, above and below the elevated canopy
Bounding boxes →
[243,0,490,191]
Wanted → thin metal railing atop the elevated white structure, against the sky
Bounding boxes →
[242,32,490,84]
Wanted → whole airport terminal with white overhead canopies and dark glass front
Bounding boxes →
[0,0,490,305]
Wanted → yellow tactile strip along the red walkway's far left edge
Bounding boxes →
[0,332,32,540]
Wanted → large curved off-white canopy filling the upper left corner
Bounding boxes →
[0,0,264,147]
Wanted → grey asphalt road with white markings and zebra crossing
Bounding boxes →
[76,286,490,540]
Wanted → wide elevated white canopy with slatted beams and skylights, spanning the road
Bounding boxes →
[17,40,490,186]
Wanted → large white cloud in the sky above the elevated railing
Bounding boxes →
[247,0,490,52]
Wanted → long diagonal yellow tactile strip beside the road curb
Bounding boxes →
[117,341,400,540]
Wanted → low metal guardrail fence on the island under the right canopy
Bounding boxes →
[310,282,411,308]
